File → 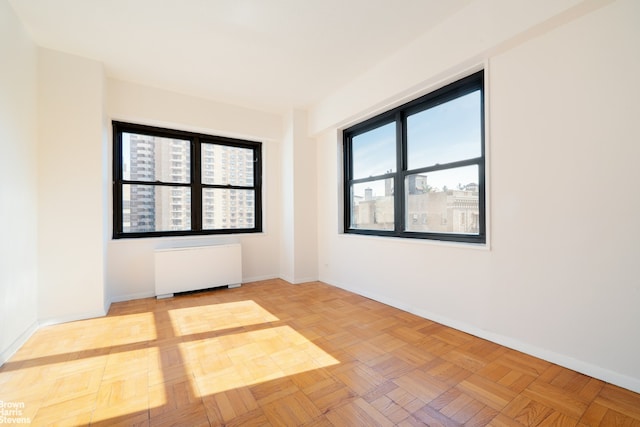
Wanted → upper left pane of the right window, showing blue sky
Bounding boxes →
[351,122,396,179]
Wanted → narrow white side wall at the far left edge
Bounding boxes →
[0,0,38,364]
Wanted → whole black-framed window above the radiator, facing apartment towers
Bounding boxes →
[113,121,262,239]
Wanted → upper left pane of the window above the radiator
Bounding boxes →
[122,132,191,184]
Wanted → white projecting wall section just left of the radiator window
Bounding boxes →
[38,49,107,323]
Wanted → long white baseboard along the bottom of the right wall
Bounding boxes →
[326,282,640,393]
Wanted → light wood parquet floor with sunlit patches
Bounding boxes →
[0,280,640,426]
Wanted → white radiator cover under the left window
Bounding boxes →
[154,244,242,298]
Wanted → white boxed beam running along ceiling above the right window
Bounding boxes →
[309,0,613,134]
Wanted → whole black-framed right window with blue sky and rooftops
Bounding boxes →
[343,71,486,243]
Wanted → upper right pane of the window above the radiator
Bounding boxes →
[202,144,254,187]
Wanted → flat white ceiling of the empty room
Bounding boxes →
[9,0,471,112]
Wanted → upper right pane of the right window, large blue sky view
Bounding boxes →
[407,90,482,169]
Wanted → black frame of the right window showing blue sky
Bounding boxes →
[342,70,487,244]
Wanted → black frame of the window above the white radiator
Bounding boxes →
[112,120,262,239]
